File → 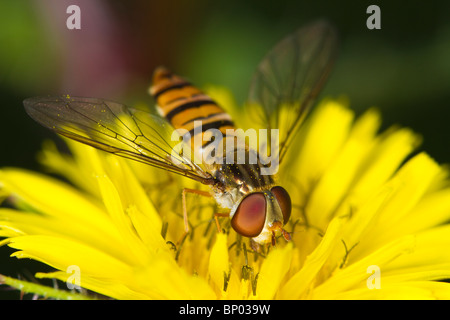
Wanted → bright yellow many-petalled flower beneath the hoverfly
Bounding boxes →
[0,89,450,299]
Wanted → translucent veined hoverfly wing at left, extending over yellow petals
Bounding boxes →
[24,96,211,184]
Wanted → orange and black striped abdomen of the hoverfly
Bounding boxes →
[150,67,234,150]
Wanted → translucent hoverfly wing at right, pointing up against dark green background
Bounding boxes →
[248,20,337,162]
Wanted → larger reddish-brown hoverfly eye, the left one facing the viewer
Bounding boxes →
[231,192,266,237]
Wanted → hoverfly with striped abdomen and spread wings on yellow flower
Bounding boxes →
[24,21,337,245]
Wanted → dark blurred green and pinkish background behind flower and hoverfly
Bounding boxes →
[0,0,450,298]
